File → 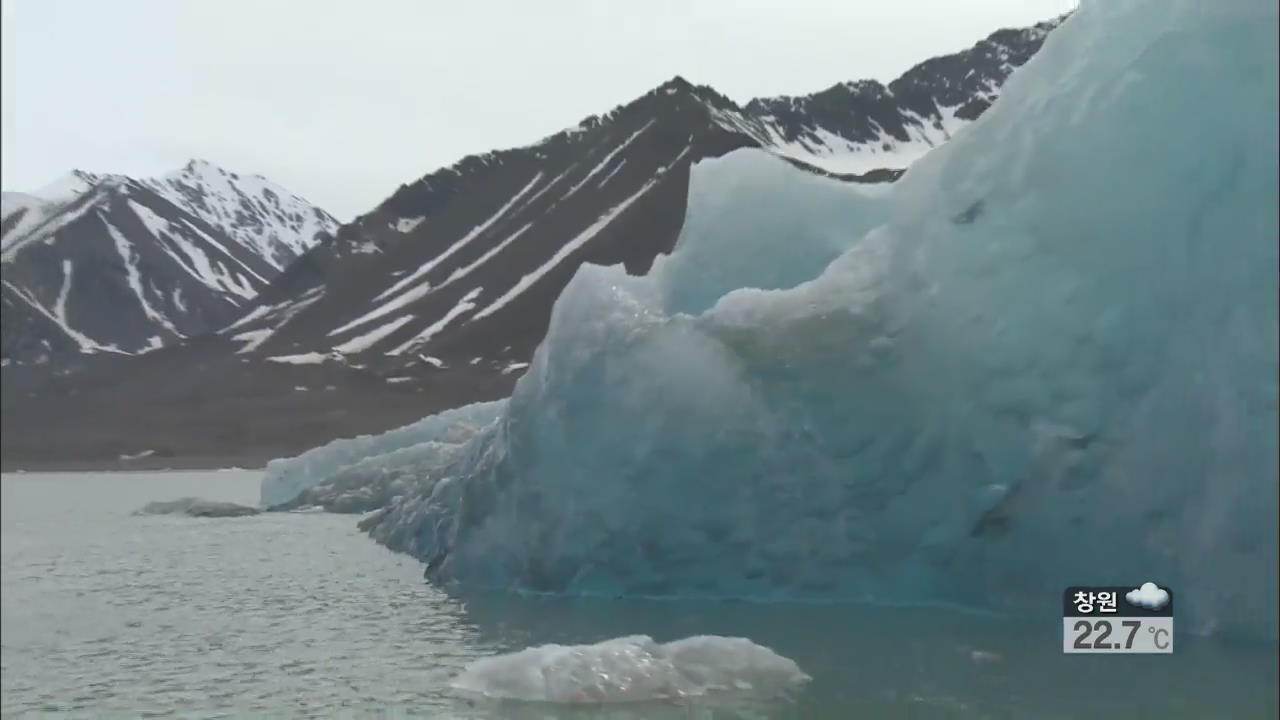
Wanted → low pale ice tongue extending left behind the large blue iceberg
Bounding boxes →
[261,401,506,507]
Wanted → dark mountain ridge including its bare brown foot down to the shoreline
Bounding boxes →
[3,18,1061,468]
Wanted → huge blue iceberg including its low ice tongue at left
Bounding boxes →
[264,0,1280,641]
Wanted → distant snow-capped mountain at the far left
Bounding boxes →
[0,160,338,361]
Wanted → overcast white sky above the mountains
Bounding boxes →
[0,0,1076,220]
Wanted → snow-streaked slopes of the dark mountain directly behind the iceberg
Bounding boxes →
[225,19,1060,370]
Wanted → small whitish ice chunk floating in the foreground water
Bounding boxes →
[453,635,809,703]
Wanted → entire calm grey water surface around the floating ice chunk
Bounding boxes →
[0,471,1277,719]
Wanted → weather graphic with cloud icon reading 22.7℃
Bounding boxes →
[1062,583,1174,653]
